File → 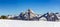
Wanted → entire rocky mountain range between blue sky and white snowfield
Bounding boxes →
[0,9,60,21]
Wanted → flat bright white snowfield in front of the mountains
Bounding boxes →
[0,19,60,27]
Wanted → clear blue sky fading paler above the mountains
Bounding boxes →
[0,0,60,15]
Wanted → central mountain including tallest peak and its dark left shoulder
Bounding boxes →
[19,9,36,20]
